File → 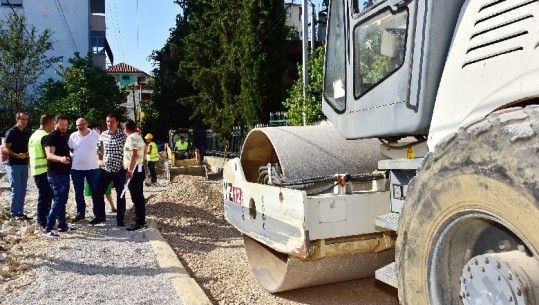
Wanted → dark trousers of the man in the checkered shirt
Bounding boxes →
[93,169,127,223]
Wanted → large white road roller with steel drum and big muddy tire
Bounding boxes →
[223,0,539,305]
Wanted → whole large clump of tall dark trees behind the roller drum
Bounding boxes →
[146,0,289,138]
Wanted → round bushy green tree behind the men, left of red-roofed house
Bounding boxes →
[35,53,126,127]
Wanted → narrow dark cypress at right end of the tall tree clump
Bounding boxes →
[240,0,290,127]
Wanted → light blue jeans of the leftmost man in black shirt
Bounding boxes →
[6,165,28,216]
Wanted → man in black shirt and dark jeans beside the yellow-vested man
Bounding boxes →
[43,115,74,237]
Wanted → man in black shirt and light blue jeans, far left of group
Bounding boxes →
[3,112,32,220]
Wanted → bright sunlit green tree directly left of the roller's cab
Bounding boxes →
[284,47,326,126]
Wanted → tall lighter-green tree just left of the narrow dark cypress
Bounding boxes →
[178,0,244,135]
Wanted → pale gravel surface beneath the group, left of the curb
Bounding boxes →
[0,173,181,305]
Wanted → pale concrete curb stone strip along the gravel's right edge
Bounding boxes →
[144,217,212,305]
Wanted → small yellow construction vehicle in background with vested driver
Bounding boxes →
[165,128,207,181]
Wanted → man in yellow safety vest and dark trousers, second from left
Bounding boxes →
[28,114,54,229]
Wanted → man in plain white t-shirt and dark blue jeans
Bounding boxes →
[69,118,99,223]
